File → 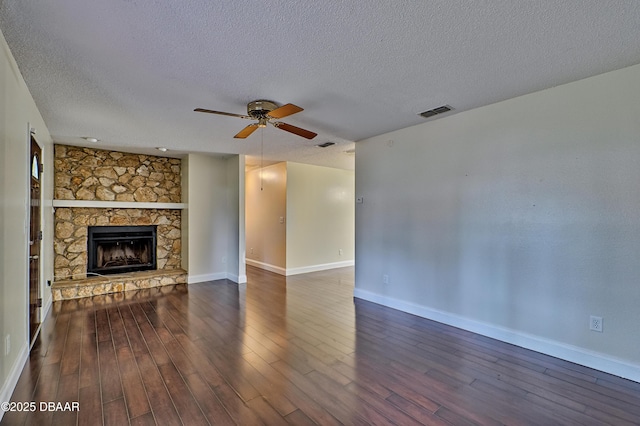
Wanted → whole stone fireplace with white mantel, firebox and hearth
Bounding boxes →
[52,145,186,300]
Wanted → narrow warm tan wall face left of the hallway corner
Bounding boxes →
[245,163,287,274]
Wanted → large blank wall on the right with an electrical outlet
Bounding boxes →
[356,65,640,381]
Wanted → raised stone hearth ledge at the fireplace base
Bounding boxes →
[51,269,187,302]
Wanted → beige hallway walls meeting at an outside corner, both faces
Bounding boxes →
[246,163,355,275]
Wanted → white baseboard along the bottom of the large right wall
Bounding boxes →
[353,288,640,382]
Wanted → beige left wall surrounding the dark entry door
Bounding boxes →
[0,28,53,408]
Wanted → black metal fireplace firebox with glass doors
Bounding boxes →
[87,225,157,275]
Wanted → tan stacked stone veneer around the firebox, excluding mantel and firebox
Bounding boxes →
[53,145,186,300]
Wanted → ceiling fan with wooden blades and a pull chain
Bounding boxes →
[194,99,317,139]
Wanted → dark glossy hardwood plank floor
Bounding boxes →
[2,268,640,426]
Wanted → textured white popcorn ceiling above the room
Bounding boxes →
[0,0,640,168]
